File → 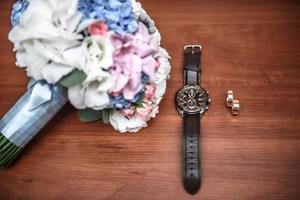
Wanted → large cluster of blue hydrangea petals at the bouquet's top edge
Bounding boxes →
[78,0,138,35]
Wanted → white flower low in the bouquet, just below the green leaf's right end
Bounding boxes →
[68,68,114,110]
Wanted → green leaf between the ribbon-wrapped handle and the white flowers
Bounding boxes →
[59,69,87,88]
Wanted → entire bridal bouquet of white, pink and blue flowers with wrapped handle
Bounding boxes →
[0,0,171,166]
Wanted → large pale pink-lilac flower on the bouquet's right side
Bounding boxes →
[110,23,160,100]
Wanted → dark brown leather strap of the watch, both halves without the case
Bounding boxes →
[183,46,201,194]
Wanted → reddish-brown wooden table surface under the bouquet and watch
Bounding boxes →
[0,0,300,200]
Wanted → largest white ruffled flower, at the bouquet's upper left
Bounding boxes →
[9,0,92,83]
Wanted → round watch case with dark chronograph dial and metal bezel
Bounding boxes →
[176,85,210,114]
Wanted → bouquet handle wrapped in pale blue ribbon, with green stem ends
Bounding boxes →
[0,80,68,167]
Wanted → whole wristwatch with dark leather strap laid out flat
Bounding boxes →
[176,45,211,194]
